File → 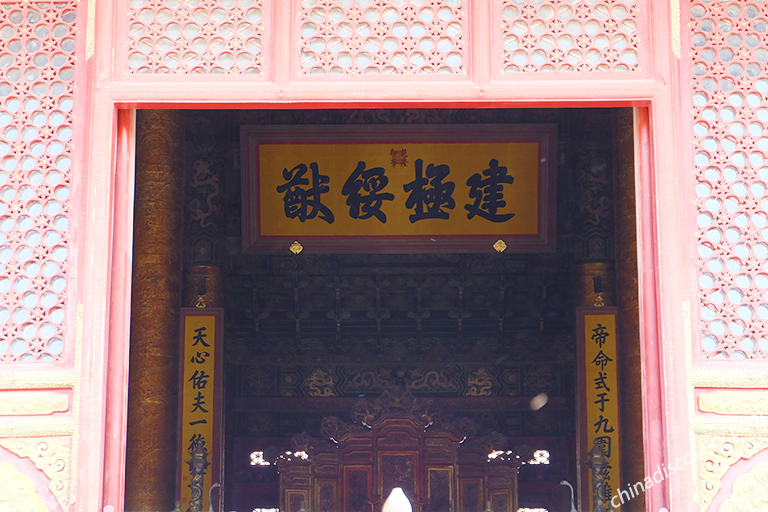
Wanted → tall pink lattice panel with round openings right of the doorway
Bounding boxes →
[689,0,768,359]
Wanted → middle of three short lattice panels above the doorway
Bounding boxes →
[298,0,466,75]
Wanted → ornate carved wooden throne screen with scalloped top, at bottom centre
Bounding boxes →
[277,392,521,512]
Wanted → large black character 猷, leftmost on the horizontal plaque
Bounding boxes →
[277,162,335,224]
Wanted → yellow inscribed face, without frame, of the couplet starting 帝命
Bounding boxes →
[579,308,621,510]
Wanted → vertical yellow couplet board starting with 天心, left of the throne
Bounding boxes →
[177,308,224,510]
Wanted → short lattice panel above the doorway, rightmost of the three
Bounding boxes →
[498,0,640,75]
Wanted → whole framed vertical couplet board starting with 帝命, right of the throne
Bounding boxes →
[576,307,621,510]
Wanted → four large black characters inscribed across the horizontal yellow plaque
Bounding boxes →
[277,158,515,224]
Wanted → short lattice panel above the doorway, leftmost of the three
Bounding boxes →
[125,0,264,75]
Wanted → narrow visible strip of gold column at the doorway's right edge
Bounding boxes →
[613,108,645,512]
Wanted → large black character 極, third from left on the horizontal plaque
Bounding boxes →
[403,158,456,223]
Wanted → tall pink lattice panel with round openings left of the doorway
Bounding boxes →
[0,0,76,362]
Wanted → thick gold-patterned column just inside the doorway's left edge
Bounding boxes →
[125,110,185,511]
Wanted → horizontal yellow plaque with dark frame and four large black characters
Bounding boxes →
[242,125,554,252]
